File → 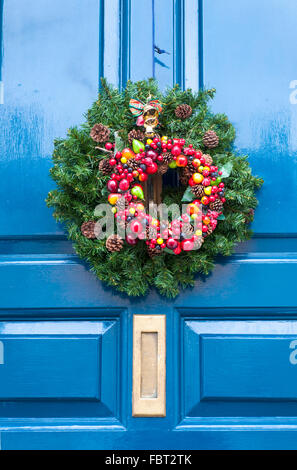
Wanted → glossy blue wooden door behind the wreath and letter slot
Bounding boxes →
[0,0,297,449]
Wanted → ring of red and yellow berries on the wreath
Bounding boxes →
[100,137,225,254]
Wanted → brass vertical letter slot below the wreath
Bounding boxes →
[132,315,166,417]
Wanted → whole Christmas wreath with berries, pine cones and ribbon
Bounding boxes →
[47,79,263,297]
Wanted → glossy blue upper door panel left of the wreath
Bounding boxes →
[0,0,99,236]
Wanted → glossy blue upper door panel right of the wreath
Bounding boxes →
[203,0,297,234]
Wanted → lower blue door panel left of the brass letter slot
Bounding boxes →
[0,317,122,425]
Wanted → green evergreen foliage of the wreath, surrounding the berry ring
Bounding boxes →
[47,79,263,298]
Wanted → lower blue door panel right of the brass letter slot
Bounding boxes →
[181,317,297,426]
